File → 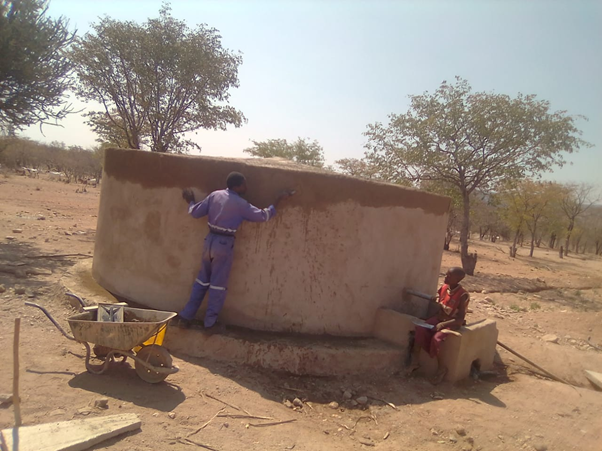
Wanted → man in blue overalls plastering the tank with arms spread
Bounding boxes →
[178,172,294,332]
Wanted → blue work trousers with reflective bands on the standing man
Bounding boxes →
[180,233,234,327]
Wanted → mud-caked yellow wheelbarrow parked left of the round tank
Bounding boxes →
[25,293,179,384]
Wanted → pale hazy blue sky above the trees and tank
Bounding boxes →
[25,0,602,183]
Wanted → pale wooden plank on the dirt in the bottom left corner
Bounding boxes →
[0,413,141,451]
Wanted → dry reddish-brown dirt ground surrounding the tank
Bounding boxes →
[0,176,602,451]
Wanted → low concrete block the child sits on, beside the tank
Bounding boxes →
[373,308,498,382]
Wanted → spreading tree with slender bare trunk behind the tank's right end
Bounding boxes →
[365,77,588,275]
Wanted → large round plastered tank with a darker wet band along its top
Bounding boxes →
[93,149,449,336]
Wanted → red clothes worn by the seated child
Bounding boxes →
[414,284,470,358]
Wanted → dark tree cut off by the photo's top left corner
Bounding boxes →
[0,0,75,129]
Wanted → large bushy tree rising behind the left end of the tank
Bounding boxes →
[71,4,245,152]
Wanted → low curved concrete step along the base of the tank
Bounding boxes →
[164,327,405,376]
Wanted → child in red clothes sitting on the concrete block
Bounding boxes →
[408,268,470,384]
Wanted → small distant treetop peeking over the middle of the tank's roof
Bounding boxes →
[243,138,324,168]
